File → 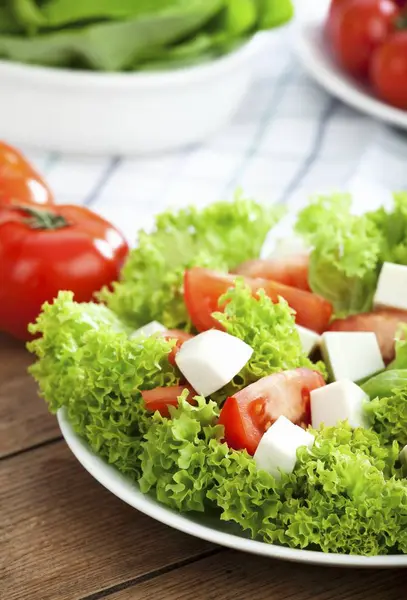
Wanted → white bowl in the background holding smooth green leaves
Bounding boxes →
[0,34,267,154]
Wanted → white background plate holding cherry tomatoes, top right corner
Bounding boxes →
[293,0,407,129]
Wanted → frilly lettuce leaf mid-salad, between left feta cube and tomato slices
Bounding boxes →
[212,277,326,402]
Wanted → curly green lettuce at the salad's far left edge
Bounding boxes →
[28,292,179,477]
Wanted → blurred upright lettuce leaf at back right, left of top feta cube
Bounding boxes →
[296,194,382,316]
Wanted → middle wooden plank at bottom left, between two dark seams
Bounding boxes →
[0,441,215,600]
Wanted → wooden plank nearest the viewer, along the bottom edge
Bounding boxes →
[104,551,407,600]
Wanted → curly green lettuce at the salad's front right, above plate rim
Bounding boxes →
[212,423,407,556]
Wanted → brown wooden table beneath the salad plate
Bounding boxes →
[0,335,407,600]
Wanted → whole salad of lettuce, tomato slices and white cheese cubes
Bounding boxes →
[28,193,407,556]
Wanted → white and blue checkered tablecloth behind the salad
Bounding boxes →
[17,17,407,246]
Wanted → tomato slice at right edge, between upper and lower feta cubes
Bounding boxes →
[329,309,407,363]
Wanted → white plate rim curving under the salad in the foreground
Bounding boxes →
[58,409,407,568]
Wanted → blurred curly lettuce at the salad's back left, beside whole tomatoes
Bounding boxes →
[101,195,281,328]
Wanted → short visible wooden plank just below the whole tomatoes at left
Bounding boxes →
[0,334,59,457]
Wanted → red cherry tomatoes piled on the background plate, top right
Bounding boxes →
[326,0,407,110]
